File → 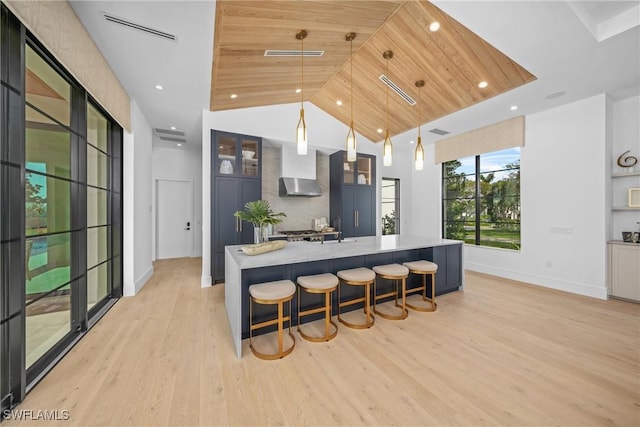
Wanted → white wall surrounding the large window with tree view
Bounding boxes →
[413,95,609,298]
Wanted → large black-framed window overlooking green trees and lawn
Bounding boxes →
[442,147,520,250]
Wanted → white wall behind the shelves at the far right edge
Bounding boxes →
[608,96,640,240]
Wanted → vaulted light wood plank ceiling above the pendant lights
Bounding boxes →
[210,0,535,142]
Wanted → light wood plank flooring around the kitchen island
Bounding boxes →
[3,259,640,427]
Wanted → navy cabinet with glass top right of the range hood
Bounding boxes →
[329,151,376,237]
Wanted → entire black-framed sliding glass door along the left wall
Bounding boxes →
[0,4,122,414]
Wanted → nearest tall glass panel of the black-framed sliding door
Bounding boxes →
[25,42,78,368]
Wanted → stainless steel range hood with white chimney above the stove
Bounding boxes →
[279,146,322,197]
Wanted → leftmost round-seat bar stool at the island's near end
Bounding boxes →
[249,280,296,360]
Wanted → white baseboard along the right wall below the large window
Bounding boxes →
[465,263,608,300]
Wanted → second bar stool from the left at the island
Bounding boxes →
[297,273,339,342]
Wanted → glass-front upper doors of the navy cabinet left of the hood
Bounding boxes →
[214,132,261,178]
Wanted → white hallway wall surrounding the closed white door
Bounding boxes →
[152,147,202,259]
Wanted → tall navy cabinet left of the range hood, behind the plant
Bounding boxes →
[211,130,262,282]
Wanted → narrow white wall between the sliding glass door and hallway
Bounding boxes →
[123,101,153,296]
